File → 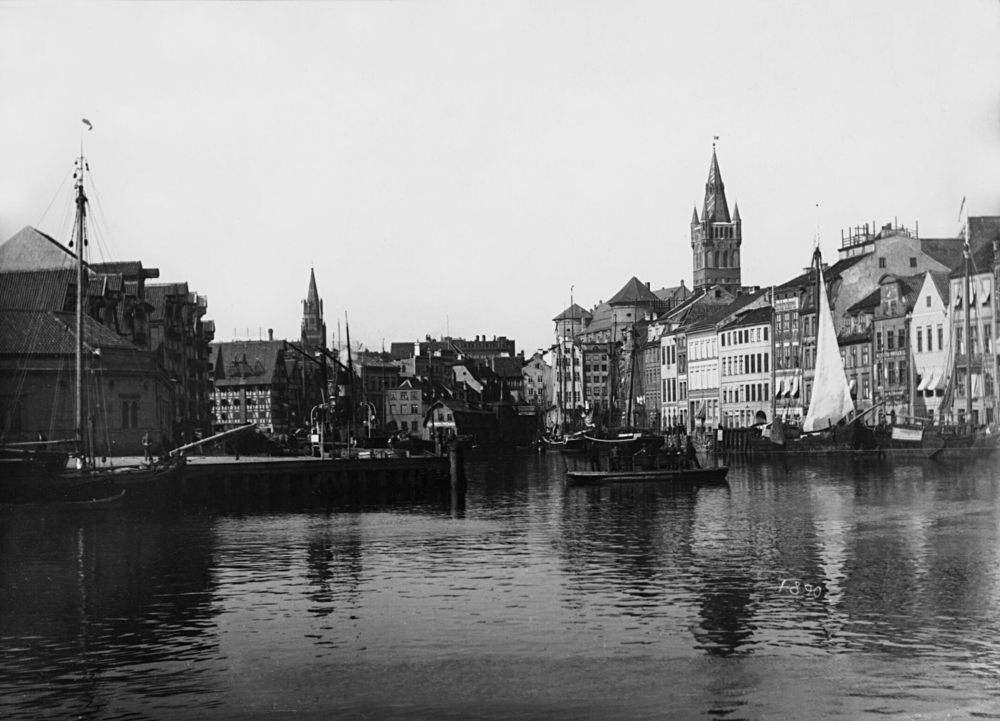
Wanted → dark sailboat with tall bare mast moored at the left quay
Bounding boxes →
[0,143,185,508]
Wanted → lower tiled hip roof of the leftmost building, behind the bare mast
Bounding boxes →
[0,309,137,355]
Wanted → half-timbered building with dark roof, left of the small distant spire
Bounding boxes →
[211,338,295,433]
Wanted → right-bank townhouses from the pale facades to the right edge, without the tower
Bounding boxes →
[647,218,1000,431]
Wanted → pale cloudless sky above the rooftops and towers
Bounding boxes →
[0,0,1000,355]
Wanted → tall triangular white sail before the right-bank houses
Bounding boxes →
[802,264,854,433]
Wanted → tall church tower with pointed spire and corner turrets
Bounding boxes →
[691,143,743,295]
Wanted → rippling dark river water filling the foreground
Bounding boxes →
[0,453,1000,719]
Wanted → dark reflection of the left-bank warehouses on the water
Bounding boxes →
[0,510,223,717]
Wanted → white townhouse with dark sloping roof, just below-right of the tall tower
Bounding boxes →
[719,305,775,428]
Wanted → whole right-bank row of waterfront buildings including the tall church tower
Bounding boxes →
[553,146,1000,430]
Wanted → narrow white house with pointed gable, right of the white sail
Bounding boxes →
[909,271,953,423]
